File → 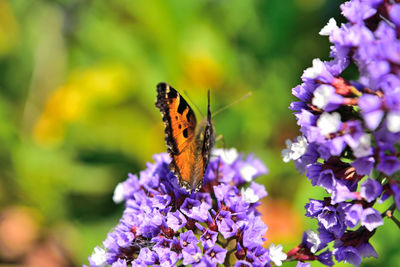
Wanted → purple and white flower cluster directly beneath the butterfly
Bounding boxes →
[89,149,272,266]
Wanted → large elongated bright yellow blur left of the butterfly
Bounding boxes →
[34,65,130,145]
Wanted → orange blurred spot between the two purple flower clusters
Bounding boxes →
[258,198,302,246]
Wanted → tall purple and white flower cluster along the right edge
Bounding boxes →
[282,0,400,266]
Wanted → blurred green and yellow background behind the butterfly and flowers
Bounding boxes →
[0,0,400,266]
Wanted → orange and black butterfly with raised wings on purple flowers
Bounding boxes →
[156,82,215,192]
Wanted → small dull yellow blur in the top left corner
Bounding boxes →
[0,0,19,56]
